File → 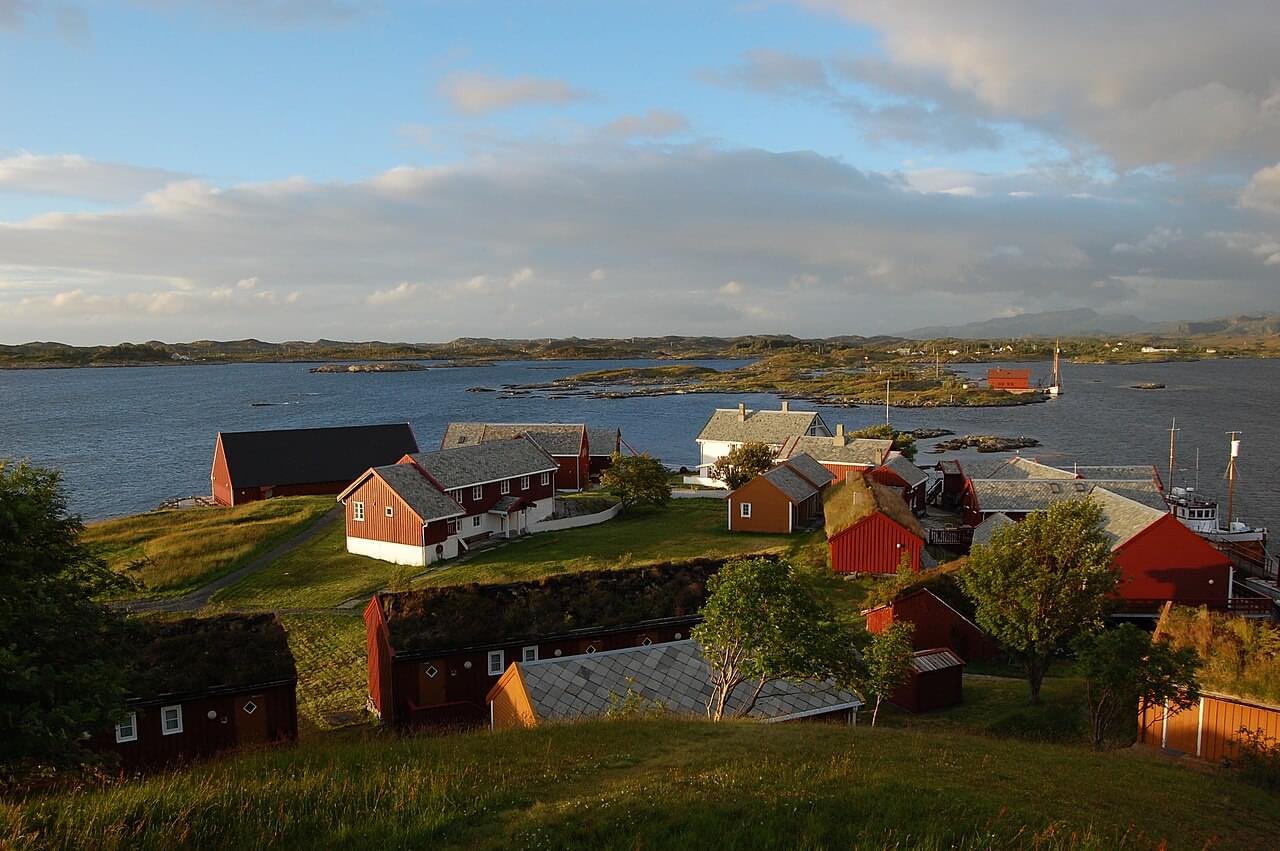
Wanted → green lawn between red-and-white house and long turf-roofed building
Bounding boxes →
[422,499,818,585]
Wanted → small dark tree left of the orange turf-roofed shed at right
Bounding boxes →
[1076,623,1199,750]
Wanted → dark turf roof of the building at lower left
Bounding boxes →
[129,614,297,704]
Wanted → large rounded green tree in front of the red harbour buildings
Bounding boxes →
[956,499,1116,704]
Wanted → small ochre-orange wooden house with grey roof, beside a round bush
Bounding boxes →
[724,454,832,535]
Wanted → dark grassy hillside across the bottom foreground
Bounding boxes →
[0,720,1280,851]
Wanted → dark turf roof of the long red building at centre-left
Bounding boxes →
[378,561,722,655]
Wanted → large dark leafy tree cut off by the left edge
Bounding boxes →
[0,461,128,778]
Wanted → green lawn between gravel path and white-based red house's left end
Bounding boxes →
[212,522,389,609]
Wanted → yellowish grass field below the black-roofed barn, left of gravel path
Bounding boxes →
[84,497,334,596]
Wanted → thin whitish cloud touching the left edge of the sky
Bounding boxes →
[0,154,186,202]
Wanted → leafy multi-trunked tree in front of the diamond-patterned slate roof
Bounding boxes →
[692,558,858,720]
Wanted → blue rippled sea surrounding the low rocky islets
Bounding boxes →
[0,350,1280,527]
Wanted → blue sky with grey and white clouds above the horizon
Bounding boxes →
[0,0,1280,344]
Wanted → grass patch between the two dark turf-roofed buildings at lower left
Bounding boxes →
[284,610,367,738]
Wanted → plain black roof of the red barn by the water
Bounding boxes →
[218,422,417,488]
